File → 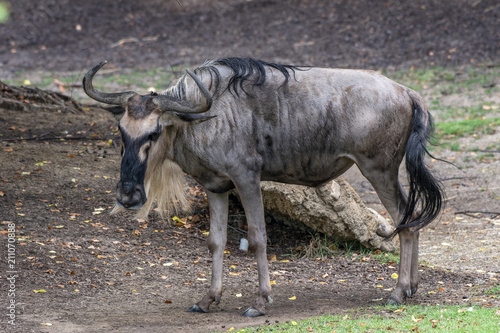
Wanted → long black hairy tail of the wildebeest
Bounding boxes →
[395,96,444,233]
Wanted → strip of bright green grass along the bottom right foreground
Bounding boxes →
[232,306,500,333]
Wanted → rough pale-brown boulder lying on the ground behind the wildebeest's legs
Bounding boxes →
[261,177,398,251]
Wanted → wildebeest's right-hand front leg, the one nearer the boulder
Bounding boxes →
[236,181,272,317]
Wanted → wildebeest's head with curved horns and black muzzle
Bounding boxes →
[83,61,212,215]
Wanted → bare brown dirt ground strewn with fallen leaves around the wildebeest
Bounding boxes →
[0,0,500,332]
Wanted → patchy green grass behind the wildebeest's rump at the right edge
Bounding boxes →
[383,65,500,151]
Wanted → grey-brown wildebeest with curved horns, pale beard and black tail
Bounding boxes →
[83,58,442,316]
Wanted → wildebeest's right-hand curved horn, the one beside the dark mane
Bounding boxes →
[153,69,212,113]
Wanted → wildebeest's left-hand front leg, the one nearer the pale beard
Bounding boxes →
[188,191,228,312]
